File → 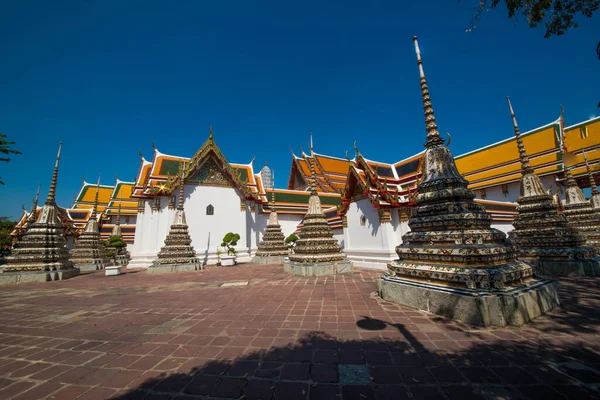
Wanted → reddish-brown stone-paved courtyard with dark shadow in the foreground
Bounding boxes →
[0,264,600,400]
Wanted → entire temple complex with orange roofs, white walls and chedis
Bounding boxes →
[0,38,600,325]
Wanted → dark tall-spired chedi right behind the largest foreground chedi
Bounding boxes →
[506,97,600,276]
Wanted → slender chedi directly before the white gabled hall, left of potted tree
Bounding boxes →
[148,164,202,273]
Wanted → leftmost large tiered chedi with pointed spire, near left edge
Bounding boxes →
[0,143,79,283]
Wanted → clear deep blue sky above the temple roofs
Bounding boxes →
[0,0,600,217]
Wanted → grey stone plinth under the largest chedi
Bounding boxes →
[377,276,560,327]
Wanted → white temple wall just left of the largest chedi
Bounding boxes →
[340,199,397,269]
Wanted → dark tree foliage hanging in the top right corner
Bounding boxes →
[459,0,600,37]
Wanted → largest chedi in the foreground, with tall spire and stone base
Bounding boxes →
[378,37,558,326]
